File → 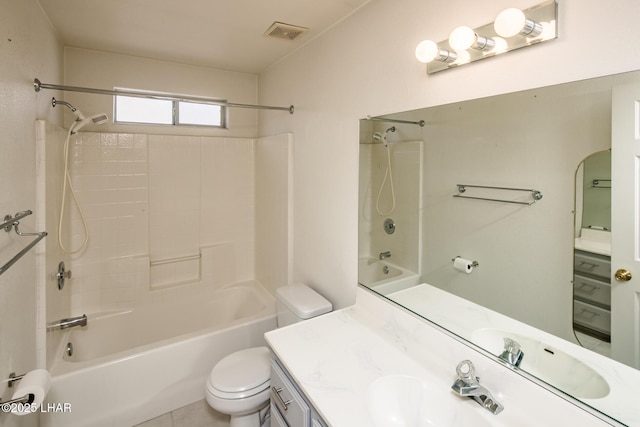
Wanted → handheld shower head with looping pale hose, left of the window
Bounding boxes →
[51,98,109,254]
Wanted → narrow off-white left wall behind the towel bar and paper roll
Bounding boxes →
[0,0,62,427]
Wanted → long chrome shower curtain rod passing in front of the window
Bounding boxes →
[33,79,294,114]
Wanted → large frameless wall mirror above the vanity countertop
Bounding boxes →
[359,71,640,425]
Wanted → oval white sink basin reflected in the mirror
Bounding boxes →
[471,328,609,399]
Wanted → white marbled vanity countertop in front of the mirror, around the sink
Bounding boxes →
[265,288,609,427]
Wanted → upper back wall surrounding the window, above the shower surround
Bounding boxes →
[62,47,258,138]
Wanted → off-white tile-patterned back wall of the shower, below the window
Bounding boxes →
[69,132,255,315]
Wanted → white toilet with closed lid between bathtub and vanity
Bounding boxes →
[205,284,332,427]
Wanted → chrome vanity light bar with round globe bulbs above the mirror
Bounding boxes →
[415,0,558,74]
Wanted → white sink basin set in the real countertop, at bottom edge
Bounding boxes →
[367,375,491,427]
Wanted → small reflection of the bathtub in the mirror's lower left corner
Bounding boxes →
[358,258,420,295]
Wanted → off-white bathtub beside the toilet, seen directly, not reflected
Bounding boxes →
[40,281,276,427]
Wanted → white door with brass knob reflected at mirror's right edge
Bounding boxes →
[611,84,640,368]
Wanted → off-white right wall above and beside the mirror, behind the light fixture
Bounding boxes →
[260,0,640,307]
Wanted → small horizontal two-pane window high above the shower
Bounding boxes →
[113,89,226,127]
